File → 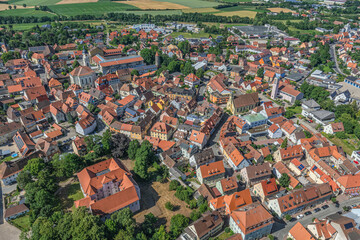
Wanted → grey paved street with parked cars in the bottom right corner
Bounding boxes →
[272,197,360,240]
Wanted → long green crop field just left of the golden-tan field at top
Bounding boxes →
[49,2,138,16]
